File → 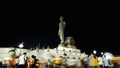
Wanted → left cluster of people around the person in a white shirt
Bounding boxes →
[0,53,40,68]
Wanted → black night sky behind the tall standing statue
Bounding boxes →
[0,4,120,54]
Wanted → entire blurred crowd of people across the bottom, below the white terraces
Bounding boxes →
[0,53,119,68]
